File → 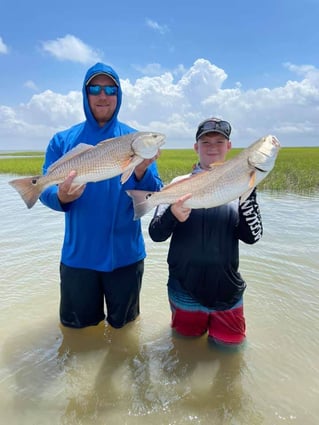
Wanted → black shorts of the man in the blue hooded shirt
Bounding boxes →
[60,260,144,328]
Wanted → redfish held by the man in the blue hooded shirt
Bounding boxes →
[9,132,165,208]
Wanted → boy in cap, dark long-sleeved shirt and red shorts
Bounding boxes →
[149,118,263,346]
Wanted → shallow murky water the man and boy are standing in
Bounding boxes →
[0,176,319,425]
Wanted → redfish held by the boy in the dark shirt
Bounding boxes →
[126,135,280,220]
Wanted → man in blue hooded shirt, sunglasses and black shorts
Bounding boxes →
[40,63,162,328]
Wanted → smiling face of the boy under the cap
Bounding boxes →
[194,132,231,170]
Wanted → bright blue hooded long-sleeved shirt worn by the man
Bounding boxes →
[40,63,162,272]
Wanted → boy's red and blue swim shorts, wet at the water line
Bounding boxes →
[169,290,246,345]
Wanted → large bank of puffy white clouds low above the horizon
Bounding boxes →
[0,59,319,149]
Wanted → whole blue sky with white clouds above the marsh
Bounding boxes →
[0,0,319,151]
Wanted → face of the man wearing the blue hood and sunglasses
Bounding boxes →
[88,75,117,127]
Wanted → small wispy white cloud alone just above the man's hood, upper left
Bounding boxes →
[42,34,101,64]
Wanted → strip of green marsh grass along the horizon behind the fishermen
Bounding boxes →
[0,147,319,194]
